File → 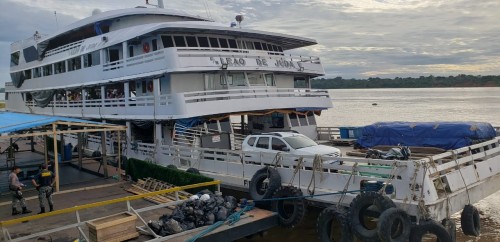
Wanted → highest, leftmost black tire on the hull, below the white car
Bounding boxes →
[248,166,281,201]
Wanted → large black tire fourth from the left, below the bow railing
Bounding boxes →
[350,192,396,242]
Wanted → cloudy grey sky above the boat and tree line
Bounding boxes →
[0,0,500,86]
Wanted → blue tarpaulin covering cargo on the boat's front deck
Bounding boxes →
[357,122,496,150]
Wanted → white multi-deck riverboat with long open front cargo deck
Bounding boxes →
[6,1,500,240]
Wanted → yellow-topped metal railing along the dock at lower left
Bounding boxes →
[0,180,221,242]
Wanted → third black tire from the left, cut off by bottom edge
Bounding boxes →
[316,205,354,242]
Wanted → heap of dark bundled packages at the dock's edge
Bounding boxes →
[148,191,238,236]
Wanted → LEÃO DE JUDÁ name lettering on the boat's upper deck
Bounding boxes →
[210,57,302,70]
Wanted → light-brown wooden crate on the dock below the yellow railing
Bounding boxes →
[87,212,139,242]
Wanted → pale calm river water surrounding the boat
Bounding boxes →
[241,87,500,242]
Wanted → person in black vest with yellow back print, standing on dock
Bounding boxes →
[31,164,55,214]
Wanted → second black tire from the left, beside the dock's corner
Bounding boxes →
[271,186,307,228]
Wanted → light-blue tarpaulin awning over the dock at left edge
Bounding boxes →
[0,112,98,134]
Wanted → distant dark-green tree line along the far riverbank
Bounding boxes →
[311,74,500,89]
